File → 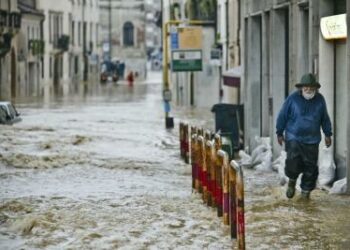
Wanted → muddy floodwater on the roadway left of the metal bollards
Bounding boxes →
[0,74,231,249]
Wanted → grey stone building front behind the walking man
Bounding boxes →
[241,0,350,179]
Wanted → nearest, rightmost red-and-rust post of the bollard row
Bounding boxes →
[236,164,245,250]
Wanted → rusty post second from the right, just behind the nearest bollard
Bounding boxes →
[229,161,237,239]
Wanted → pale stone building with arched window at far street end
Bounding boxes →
[99,0,147,78]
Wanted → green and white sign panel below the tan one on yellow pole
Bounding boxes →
[171,49,203,72]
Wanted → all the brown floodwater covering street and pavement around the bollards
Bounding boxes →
[0,72,350,249]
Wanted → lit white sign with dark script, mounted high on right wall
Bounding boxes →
[321,14,347,40]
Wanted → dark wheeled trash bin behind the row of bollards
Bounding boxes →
[211,103,244,154]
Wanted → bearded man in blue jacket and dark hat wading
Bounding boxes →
[276,74,332,199]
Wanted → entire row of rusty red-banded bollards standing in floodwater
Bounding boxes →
[180,122,245,249]
